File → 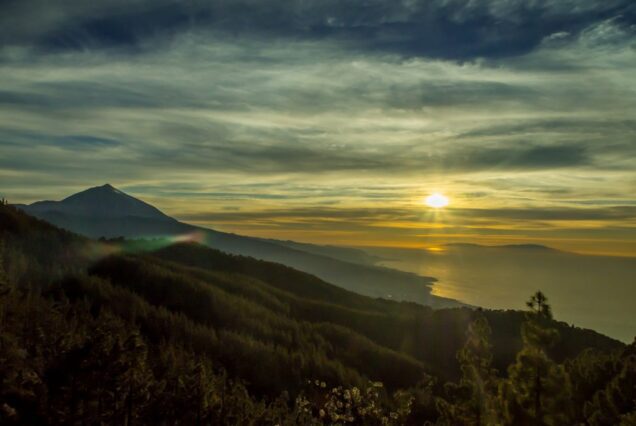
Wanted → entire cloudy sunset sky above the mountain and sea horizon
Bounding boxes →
[0,0,636,256]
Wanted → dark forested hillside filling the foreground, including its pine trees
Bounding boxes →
[0,205,636,425]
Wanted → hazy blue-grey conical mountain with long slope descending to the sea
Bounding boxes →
[16,184,464,307]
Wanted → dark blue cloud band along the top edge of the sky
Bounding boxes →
[0,0,635,59]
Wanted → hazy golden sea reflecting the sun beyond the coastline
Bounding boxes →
[376,250,636,342]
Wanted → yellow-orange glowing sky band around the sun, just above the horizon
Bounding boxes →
[11,180,636,257]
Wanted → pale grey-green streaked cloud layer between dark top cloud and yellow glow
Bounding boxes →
[0,26,636,183]
